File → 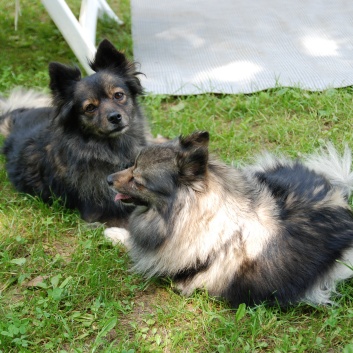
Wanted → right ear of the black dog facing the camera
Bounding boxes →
[89,39,143,94]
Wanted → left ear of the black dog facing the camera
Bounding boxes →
[49,62,81,102]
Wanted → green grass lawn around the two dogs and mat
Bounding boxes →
[0,0,353,353]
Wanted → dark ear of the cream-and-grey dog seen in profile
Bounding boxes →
[177,131,209,191]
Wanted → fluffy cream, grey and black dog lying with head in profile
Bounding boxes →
[105,132,353,307]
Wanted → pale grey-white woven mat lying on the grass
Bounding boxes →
[131,0,353,95]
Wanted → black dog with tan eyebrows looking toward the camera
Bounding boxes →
[0,40,147,224]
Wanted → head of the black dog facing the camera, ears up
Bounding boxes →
[49,40,143,138]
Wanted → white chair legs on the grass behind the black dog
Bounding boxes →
[42,0,123,74]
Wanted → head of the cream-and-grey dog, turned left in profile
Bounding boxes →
[107,131,209,207]
